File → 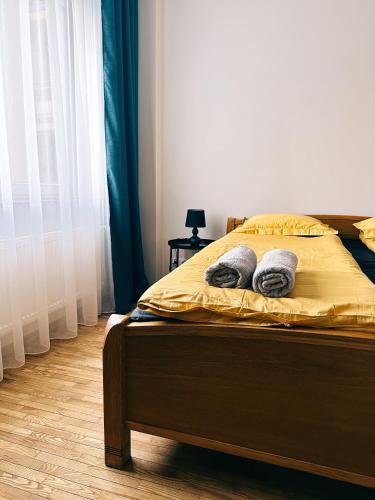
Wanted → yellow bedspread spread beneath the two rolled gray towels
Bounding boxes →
[138,232,375,331]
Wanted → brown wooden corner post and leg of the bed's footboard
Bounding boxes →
[103,314,130,469]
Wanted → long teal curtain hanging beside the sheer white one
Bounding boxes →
[102,0,148,313]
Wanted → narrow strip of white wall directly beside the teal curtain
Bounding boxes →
[139,0,163,282]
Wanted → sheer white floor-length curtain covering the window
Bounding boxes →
[0,0,113,380]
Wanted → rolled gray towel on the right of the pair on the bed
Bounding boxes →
[253,250,298,298]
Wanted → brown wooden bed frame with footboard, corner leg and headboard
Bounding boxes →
[103,215,375,487]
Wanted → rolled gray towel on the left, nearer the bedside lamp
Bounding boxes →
[204,246,257,288]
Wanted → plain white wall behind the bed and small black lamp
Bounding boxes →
[141,0,375,280]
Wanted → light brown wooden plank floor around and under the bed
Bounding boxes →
[0,318,374,500]
